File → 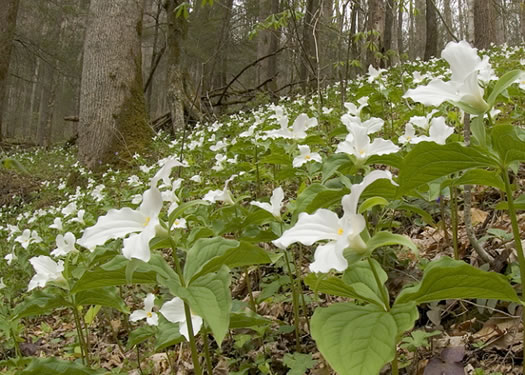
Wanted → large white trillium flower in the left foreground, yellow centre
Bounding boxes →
[78,187,162,262]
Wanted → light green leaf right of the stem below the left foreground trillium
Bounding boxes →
[184,237,239,280]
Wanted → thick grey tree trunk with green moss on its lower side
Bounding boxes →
[78,0,152,169]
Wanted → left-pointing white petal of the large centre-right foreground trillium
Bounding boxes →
[273,208,340,248]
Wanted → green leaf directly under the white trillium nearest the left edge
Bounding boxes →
[14,288,71,318]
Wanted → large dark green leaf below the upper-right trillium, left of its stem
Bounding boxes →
[398,142,498,194]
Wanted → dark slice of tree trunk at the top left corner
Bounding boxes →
[0,0,19,141]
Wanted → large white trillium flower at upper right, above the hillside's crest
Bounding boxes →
[404,41,490,114]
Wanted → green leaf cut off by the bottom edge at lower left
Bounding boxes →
[19,358,107,375]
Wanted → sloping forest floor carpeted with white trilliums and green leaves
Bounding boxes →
[0,44,525,374]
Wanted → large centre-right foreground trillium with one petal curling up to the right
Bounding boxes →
[273,170,394,272]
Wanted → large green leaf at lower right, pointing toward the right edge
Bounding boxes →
[396,257,519,304]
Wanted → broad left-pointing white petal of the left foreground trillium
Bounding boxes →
[78,207,146,250]
